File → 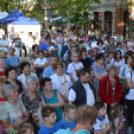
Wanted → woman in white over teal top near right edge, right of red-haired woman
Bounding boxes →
[119,55,133,84]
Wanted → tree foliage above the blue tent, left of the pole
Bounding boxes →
[0,0,45,23]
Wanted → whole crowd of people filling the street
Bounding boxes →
[0,27,134,134]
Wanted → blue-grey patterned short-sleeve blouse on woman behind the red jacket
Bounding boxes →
[93,64,107,90]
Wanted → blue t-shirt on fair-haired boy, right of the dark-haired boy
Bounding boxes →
[59,119,76,129]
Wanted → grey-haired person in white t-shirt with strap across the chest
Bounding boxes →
[67,52,83,84]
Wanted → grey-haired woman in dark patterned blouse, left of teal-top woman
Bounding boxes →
[20,75,45,128]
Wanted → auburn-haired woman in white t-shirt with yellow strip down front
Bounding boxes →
[50,61,71,101]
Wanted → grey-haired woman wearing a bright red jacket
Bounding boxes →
[100,64,122,111]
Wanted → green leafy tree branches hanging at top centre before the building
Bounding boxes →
[47,0,101,25]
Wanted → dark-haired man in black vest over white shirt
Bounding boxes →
[68,68,96,107]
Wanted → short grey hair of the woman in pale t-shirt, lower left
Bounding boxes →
[2,83,19,100]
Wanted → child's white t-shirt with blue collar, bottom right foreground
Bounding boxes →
[94,115,110,131]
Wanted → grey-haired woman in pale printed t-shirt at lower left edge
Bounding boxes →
[0,84,29,133]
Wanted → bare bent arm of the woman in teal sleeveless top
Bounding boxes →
[48,91,65,108]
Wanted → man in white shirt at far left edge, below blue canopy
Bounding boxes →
[0,34,9,52]
